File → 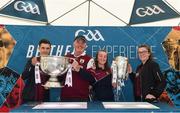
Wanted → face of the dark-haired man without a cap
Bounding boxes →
[39,43,51,56]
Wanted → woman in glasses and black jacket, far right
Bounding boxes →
[128,44,166,102]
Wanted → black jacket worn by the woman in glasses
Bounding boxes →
[130,60,166,99]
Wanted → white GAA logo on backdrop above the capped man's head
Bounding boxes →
[75,29,104,41]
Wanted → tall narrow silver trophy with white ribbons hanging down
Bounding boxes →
[111,56,128,101]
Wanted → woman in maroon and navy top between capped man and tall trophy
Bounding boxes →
[74,50,114,101]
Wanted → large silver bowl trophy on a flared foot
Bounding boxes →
[40,56,69,88]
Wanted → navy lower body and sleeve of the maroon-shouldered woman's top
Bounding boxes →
[80,69,114,101]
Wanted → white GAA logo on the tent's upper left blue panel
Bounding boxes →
[14,1,40,15]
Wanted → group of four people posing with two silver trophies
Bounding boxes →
[22,36,166,103]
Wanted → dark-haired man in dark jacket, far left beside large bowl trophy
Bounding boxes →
[22,39,51,103]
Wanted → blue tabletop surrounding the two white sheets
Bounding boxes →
[11,102,180,113]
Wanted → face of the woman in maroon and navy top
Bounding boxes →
[97,51,107,65]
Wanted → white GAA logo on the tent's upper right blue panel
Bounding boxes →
[136,5,165,17]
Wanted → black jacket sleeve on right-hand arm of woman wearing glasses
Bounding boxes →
[150,63,166,98]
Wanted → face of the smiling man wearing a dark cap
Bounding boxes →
[74,40,86,53]
